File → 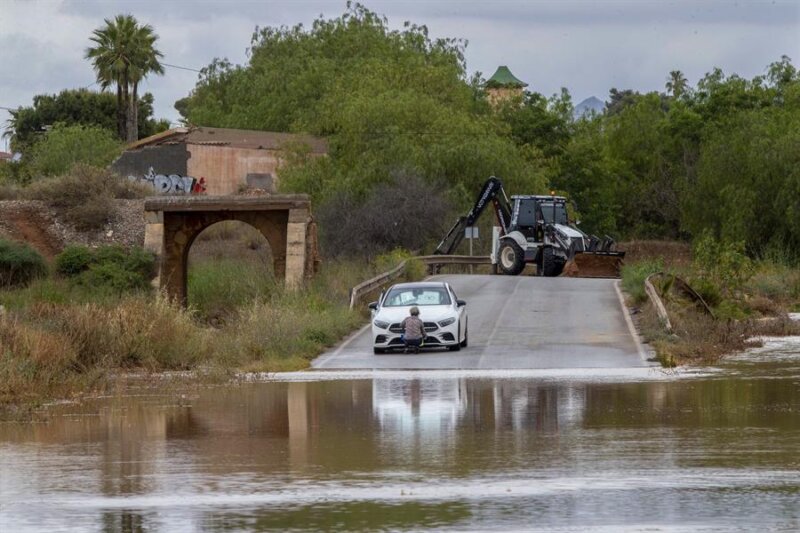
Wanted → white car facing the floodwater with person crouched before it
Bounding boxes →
[369,281,467,354]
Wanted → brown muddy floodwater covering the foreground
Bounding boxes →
[0,343,800,532]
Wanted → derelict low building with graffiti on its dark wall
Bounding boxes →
[111,127,328,196]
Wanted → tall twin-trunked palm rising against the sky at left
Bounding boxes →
[86,15,164,142]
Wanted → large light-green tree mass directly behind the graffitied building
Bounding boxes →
[179,4,546,203]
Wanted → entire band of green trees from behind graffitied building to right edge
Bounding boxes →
[181,4,800,260]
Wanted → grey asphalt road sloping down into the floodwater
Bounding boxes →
[312,275,650,370]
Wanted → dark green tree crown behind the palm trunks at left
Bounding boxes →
[6,89,169,153]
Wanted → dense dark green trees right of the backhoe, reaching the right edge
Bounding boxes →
[550,57,800,255]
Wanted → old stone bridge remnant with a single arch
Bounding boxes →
[144,194,319,304]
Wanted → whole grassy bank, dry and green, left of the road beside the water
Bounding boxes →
[0,239,412,415]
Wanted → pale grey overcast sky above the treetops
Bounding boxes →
[0,0,800,148]
